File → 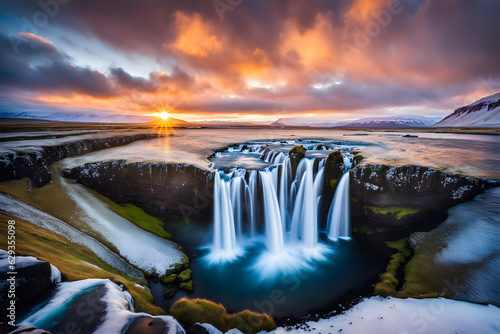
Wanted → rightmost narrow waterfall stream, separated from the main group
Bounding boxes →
[327,172,350,241]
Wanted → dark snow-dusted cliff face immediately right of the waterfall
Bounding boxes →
[350,165,498,228]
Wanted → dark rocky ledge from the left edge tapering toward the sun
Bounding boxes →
[0,133,156,187]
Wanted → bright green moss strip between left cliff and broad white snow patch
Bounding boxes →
[87,189,172,240]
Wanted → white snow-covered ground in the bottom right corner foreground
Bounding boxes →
[273,297,500,334]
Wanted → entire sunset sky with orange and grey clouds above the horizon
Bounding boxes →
[0,0,500,123]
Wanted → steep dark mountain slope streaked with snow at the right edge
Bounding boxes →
[434,93,500,127]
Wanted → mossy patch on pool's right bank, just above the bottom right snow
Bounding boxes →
[373,238,412,297]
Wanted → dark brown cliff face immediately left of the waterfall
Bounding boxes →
[63,160,213,221]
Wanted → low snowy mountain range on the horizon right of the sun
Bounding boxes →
[271,115,442,128]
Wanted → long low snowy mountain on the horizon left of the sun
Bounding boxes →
[0,111,151,123]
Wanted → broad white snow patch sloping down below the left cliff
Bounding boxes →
[61,178,185,276]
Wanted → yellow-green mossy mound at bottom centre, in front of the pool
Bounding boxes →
[170,298,276,333]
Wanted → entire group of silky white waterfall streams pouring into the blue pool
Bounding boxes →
[213,141,351,266]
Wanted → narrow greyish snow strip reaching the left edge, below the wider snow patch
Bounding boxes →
[0,193,144,278]
